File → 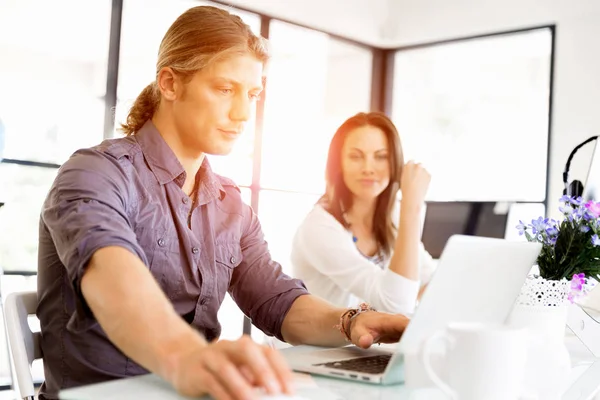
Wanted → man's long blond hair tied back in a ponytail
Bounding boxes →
[121,6,269,135]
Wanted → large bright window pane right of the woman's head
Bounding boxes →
[393,28,553,202]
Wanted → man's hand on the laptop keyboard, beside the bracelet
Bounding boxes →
[350,311,409,349]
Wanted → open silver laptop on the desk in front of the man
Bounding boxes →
[289,235,541,384]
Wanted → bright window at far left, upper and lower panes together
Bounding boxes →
[0,0,111,271]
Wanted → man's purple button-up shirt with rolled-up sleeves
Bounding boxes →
[37,121,307,398]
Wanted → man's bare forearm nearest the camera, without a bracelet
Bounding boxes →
[81,247,206,380]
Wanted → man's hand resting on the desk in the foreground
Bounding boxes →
[168,336,292,400]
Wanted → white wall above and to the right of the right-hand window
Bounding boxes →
[381,0,600,215]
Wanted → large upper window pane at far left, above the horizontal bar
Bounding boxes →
[0,0,111,163]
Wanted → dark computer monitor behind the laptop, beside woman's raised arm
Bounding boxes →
[421,202,508,259]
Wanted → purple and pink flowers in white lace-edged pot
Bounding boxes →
[508,196,600,399]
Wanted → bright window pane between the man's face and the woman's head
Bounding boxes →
[260,21,373,193]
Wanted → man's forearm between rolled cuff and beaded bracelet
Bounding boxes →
[281,295,348,347]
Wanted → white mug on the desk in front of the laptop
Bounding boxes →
[423,323,527,400]
